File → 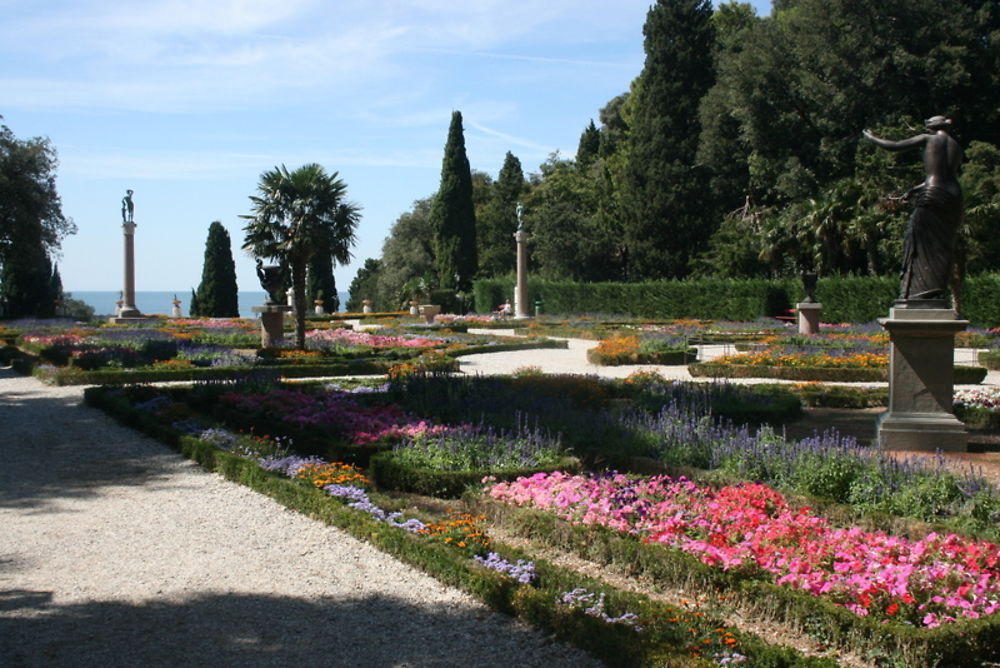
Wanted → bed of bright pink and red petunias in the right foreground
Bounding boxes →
[486,473,1000,665]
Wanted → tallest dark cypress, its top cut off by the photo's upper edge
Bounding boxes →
[622,0,715,280]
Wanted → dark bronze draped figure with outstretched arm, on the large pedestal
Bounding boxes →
[862,116,964,301]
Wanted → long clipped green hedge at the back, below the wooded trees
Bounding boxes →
[473,274,1000,327]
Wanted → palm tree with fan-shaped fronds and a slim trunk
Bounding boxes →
[241,163,361,349]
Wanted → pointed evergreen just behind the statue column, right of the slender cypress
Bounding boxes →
[477,151,525,276]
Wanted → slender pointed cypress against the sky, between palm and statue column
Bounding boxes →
[430,111,479,290]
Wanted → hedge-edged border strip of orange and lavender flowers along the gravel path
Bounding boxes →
[85,388,835,668]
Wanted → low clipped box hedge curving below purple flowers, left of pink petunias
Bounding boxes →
[368,451,580,499]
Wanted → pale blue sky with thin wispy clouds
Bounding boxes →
[0,0,770,294]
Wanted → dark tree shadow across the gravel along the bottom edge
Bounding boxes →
[0,591,601,668]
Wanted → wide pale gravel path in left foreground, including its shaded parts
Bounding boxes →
[0,369,600,668]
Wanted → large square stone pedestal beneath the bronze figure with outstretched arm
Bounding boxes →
[878,302,969,452]
